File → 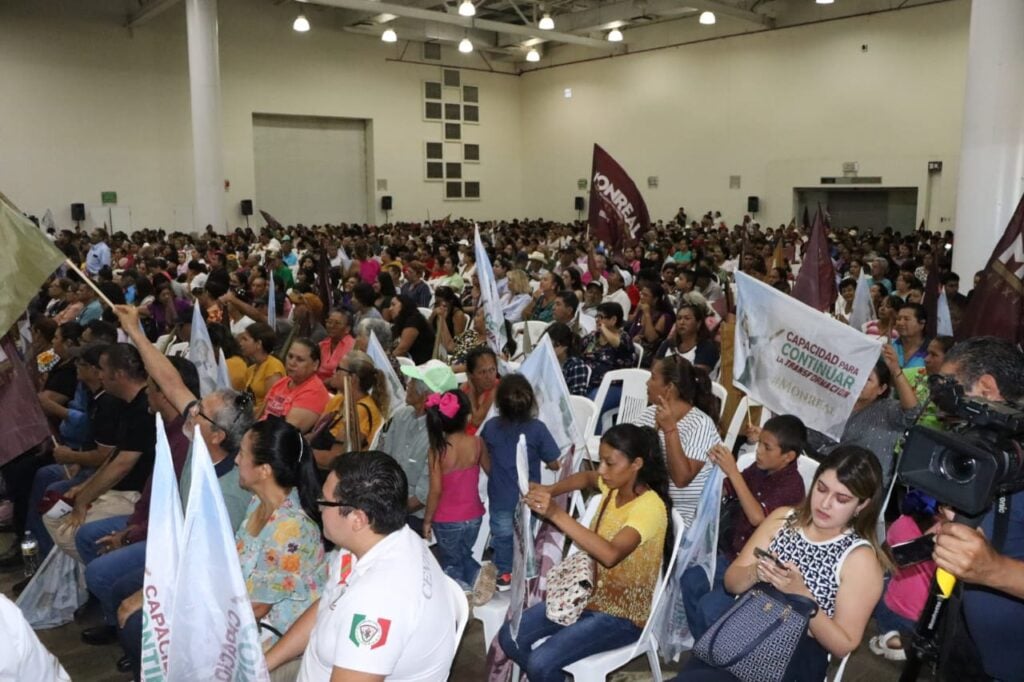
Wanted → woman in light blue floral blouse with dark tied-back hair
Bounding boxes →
[234,417,327,644]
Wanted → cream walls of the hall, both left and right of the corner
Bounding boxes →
[0,0,970,228]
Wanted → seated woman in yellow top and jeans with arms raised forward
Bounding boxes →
[498,424,674,682]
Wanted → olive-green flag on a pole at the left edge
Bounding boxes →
[0,194,65,334]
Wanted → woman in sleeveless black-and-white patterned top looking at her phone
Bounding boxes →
[677,445,889,682]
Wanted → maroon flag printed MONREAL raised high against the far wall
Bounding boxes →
[587,144,650,253]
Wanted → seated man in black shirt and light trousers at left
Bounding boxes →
[45,343,157,558]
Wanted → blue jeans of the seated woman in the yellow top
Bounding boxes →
[498,603,640,682]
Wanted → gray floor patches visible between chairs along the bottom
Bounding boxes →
[0,535,913,682]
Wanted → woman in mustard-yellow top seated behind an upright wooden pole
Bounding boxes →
[311,350,391,469]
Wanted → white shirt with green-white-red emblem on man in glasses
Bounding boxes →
[298,526,456,682]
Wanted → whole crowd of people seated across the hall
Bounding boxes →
[0,209,1024,680]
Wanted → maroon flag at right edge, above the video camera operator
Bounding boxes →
[957,191,1024,343]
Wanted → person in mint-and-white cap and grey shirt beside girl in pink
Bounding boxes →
[377,360,459,532]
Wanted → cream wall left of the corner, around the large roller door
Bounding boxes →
[0,0,521,227]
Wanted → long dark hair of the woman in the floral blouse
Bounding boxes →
[249,417,324,528]
